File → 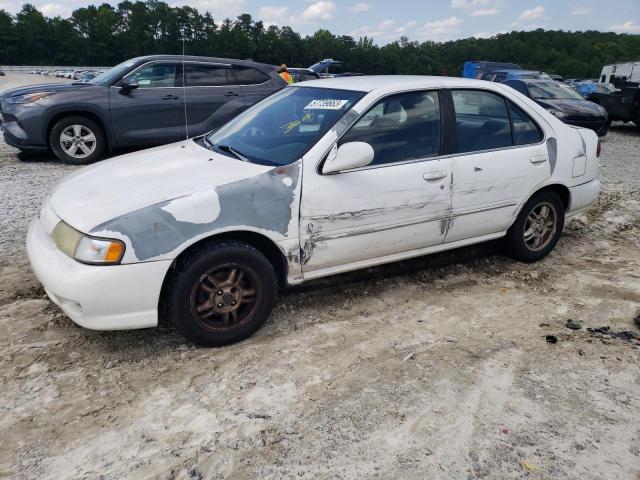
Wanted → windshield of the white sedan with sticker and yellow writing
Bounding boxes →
[206,87,364,166]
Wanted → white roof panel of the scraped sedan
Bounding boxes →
[293,75,496,92]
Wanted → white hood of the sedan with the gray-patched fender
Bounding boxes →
[49,140,273,233]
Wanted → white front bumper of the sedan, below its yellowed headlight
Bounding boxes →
[27,218,171,330]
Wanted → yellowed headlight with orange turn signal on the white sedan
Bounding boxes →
[51,222,124,265]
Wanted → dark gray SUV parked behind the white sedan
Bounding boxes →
[0,55,286,164]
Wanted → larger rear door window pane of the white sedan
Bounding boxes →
[451,90,512,153]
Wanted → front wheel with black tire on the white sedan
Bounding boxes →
[162,240,278,347]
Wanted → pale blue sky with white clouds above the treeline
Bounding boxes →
[0,0,640,44]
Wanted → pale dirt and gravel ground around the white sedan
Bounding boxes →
[0,75,640,480]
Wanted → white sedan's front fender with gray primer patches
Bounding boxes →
[90,162,301,263]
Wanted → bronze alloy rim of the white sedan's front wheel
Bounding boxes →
[190,264,262,332]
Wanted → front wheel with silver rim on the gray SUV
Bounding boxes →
[49,115,106,165]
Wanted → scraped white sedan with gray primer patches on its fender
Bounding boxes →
[27,76,600,345]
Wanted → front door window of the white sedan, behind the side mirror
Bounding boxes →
[340,92,440,165]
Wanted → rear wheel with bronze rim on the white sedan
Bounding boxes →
[505,190,564,263]
